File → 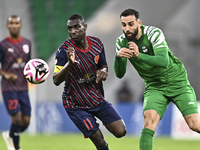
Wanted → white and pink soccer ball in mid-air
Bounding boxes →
[24,58,50,84]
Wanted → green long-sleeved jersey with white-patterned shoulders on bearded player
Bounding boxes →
[114,25,190,89]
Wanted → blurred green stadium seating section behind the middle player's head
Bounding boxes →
[30,0,106,60]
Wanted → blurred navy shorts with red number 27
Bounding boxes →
[2,91,31,116]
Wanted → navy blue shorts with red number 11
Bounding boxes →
[65,100,122,138]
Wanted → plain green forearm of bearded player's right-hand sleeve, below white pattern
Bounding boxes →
[138,50,169,68]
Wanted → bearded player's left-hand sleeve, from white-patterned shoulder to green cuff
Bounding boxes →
[114,36,127,78]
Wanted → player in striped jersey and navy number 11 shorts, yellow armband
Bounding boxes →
[53,14,126,150]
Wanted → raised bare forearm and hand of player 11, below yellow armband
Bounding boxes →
[53,47,75,86]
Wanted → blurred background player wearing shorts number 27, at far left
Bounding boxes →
[0,15,31,150]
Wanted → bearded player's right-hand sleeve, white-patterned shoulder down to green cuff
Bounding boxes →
[138,27,169,68]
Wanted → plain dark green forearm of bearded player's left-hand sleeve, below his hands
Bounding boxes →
[114,53,127,78]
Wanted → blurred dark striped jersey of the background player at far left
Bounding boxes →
[0,37,31,91]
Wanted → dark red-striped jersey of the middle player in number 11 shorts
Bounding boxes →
[56,36,107,109]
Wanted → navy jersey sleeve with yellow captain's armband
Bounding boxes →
[54,46,68,73]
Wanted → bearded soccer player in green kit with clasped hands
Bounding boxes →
[114,9,200,150]
